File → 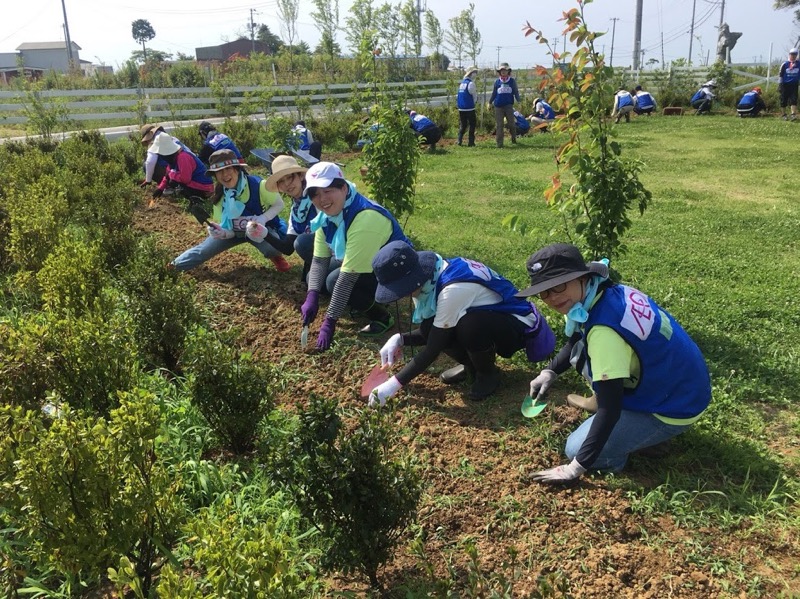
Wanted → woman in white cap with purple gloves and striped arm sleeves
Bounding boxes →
[300,162,411,350]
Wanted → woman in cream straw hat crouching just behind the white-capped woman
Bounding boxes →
[267,155,342,283]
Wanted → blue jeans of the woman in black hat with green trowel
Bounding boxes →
[564,410,691,472]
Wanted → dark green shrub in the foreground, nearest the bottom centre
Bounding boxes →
[279,397,422,588]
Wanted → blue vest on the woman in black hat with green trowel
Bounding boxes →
[582,285,711,418]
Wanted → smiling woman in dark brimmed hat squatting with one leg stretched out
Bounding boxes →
[172,150,291,272]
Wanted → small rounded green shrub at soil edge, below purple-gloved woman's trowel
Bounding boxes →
[182,327,275,453]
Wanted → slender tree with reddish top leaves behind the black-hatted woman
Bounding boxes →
[523,0,651,258]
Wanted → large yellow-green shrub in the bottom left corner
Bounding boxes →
[0,390,184,596]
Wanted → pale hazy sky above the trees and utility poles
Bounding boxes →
[6,0,800,68]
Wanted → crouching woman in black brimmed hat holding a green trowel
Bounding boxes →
[517,243,711,483]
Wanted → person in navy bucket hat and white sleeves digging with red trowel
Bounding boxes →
[369,241,556,406]
